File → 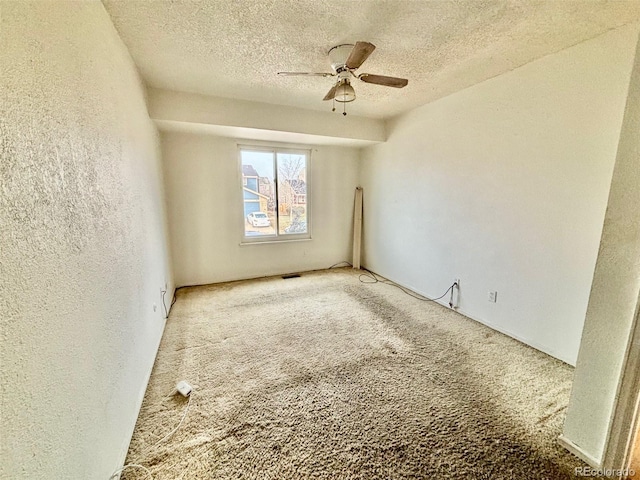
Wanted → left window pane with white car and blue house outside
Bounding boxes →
[240,150,277,237]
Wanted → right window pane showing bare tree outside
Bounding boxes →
[277,153,307,235]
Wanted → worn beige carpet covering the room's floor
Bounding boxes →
[123,269,596,480]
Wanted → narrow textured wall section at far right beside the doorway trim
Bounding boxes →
[563,32,640,468]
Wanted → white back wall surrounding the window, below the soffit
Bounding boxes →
[161,132,359,286]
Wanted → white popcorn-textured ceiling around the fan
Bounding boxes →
[103,0,640,117]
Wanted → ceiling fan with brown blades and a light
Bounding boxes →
[278,42,409,115]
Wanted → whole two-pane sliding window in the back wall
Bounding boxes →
[240,147,311,242]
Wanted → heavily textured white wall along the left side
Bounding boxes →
[0,1,171,480]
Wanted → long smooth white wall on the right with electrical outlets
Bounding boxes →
[362,24,638,364]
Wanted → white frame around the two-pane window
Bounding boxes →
[237,144,312,245]
